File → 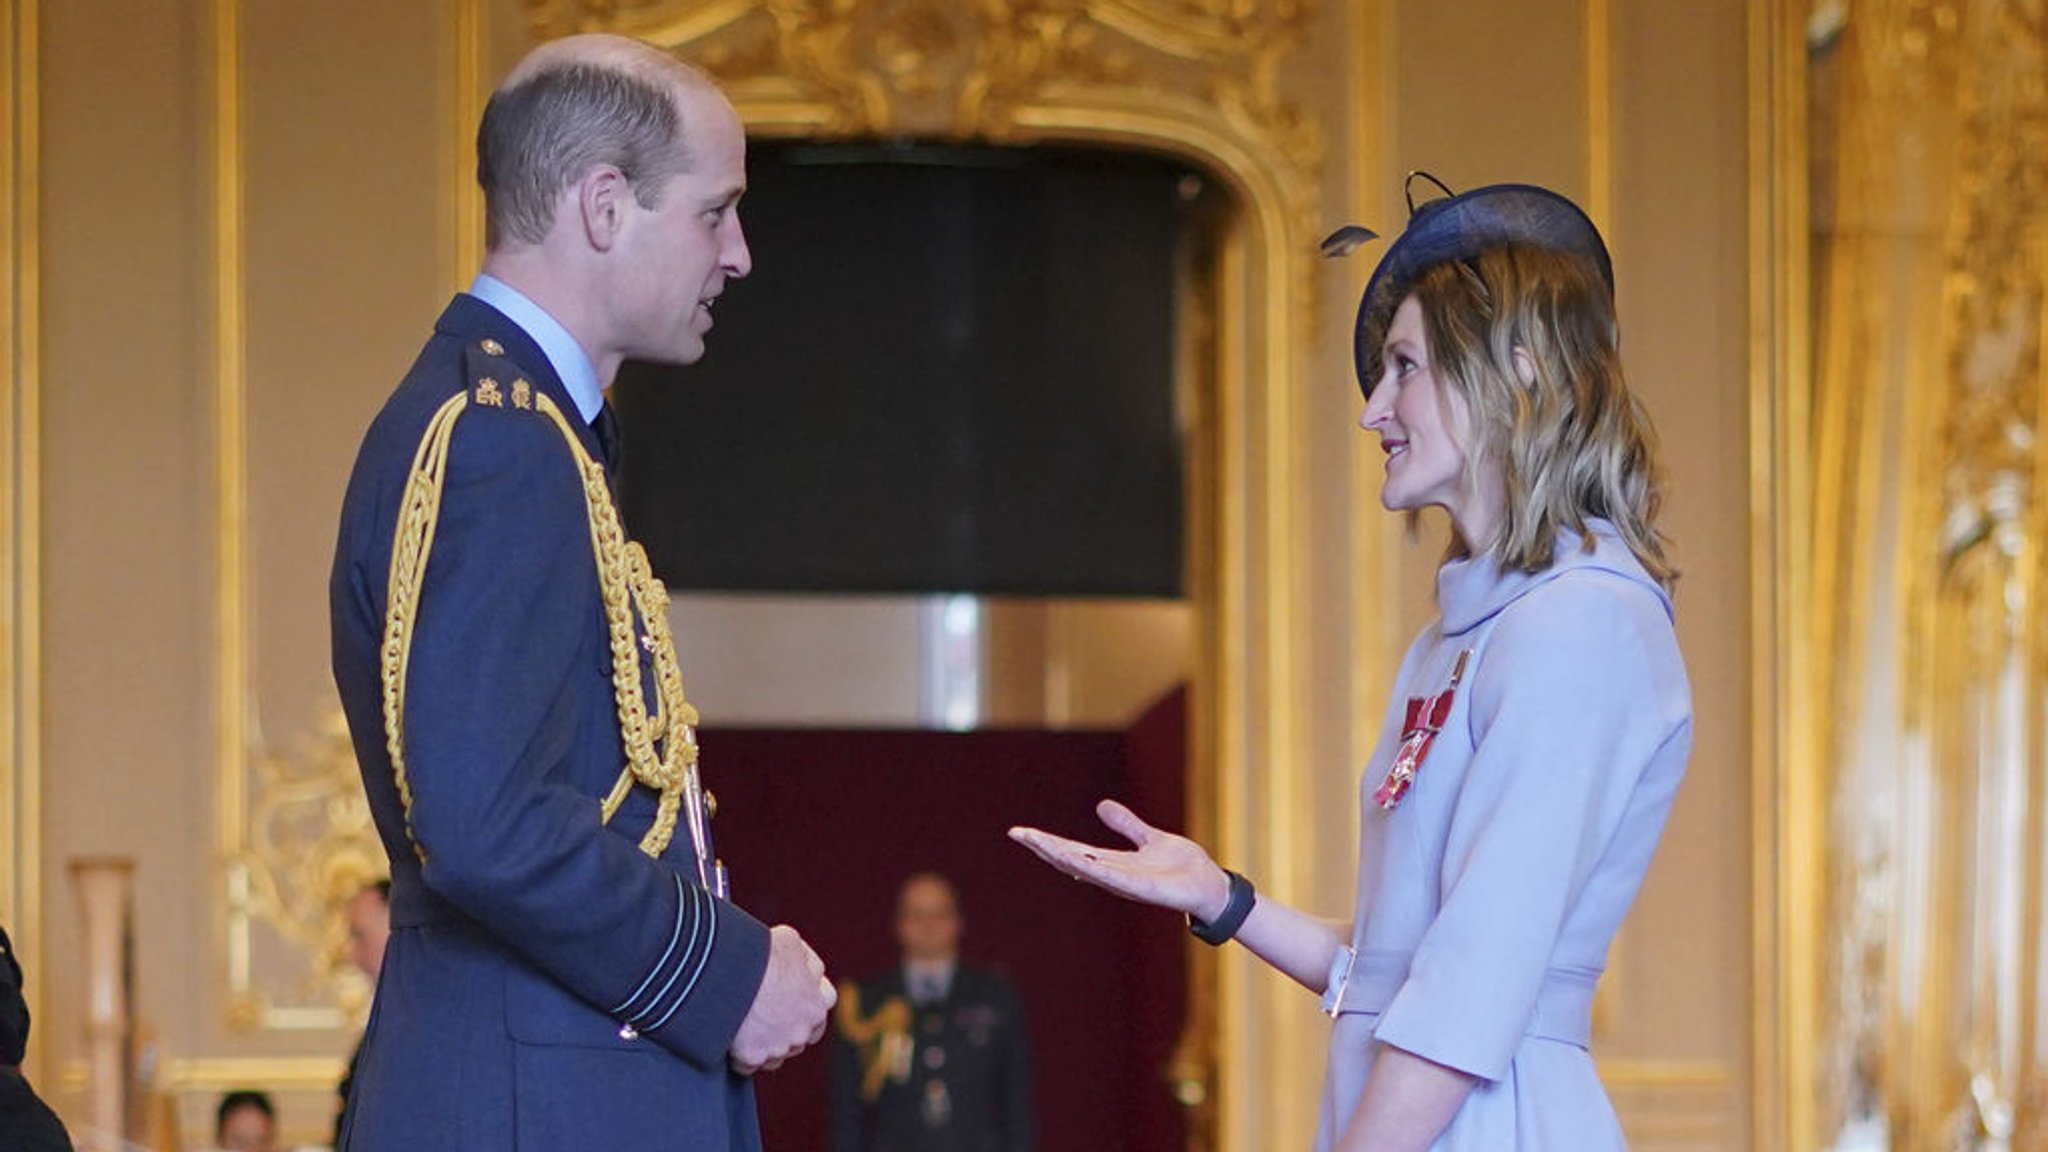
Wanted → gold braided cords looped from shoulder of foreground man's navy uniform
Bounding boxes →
[383,392,707,871]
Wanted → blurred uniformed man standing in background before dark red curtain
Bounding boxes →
[829,871,1034,1152]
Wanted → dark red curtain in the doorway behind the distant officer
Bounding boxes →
[702,691,1188,1152]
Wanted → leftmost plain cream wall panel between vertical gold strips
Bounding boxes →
[31,0,215,1115]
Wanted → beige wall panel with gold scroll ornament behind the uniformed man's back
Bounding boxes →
[214,0,487,1037]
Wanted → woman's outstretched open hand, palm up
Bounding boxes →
[1010,799,1231,920]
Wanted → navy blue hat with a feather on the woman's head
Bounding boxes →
[1323,172,1614,396]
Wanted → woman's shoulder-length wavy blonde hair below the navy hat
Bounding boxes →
[1409,244,1677,588]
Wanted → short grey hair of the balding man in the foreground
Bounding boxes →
[477,61,690,250]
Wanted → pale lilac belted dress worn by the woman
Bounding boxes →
[1317,521,1692,1152]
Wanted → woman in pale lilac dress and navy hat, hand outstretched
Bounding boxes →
[1012,175,1692,1152]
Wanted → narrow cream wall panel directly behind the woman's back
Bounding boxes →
[1612,0,1755,1090]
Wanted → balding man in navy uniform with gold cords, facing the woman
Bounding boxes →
[330,37,834,1152]
